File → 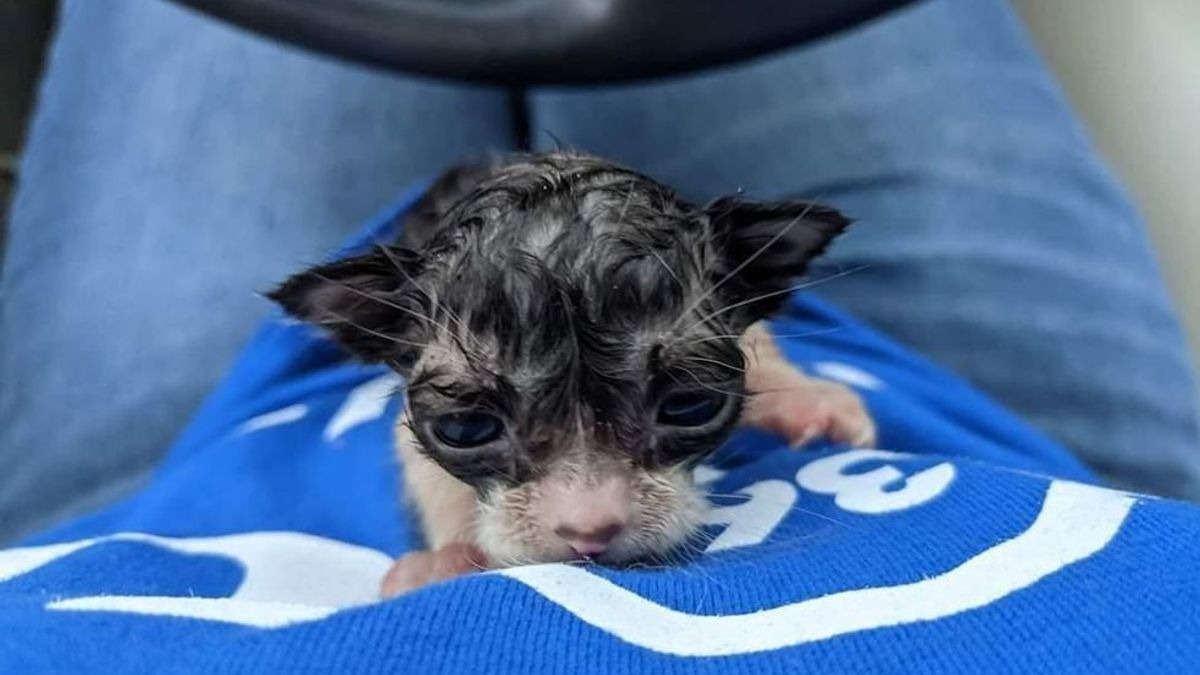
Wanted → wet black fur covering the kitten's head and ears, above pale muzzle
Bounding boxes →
[270,153,848,486]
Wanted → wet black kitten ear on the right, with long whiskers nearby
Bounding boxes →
[706,197,851,322]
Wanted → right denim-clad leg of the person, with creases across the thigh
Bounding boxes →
[533,0,1200,498]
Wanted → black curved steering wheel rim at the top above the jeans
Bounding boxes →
[179,0,910,85]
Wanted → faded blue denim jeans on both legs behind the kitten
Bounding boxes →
[0,0,1200,540]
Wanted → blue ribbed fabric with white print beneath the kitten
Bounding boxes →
[0,184,1200,675]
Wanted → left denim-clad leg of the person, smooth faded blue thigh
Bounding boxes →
[0,0,512,540]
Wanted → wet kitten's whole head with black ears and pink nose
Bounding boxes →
[271,154,847,563]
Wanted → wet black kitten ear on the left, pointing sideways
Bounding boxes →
[266,247,428,364]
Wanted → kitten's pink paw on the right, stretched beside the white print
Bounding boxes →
[742,364,876,448]
